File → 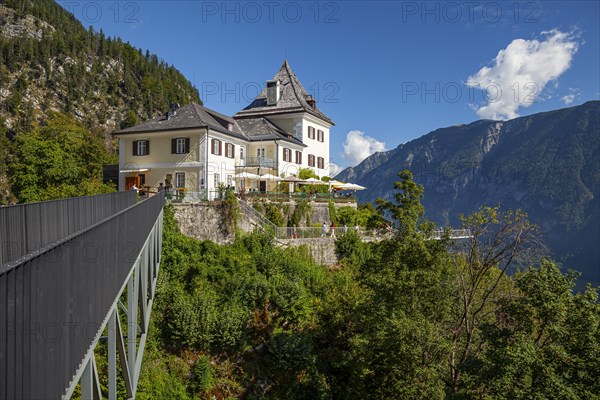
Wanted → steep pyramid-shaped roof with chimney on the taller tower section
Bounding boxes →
[234,60,333,125]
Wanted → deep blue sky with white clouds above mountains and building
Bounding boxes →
[59,0,600,166]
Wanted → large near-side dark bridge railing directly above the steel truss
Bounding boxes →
[0,194,164,399]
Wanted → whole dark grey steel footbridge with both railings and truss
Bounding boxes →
[0,191,164,400]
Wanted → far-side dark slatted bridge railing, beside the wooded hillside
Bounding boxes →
[0,191,136,265]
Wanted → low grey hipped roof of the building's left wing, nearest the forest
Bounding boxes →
[113,103,248,140]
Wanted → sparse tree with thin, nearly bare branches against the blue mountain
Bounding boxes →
[449,207,544,392]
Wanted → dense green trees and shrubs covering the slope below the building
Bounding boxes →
[138,172,600,400]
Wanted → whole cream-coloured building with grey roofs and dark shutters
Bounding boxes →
[113,61,334,198]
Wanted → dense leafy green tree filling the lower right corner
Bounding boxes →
[471,260,600,400]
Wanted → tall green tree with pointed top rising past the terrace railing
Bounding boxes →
[325,171,452,399]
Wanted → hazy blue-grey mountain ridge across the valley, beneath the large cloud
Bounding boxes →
[336,101,600,282]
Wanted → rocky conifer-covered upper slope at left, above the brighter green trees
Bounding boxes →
[0,0,200,138]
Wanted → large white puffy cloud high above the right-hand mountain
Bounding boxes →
[466,29,579,119]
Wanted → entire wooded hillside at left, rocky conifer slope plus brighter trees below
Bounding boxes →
[0,0,200,205]
